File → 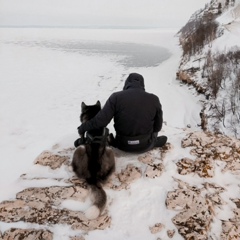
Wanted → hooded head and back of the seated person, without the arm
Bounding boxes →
[110,74,162,137]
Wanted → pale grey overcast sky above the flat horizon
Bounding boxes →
[0,0,210,28]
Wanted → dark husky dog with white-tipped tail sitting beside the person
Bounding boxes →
[72,101,115,219]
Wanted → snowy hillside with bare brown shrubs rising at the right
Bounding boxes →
[178,0,240,138]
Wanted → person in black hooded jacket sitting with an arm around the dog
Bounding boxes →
[74,73,167,152]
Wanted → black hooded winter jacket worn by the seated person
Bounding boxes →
[78,73,163,137]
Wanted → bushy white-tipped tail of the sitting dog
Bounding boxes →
[85,183,107,219]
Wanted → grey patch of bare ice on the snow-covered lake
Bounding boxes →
[3,36,171,68]
